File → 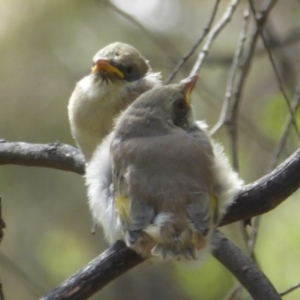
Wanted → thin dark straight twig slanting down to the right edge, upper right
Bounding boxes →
[249,0,300,139]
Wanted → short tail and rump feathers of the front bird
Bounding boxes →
[125,214,212,261]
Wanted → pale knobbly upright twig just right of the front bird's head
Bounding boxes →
[210,7,249,135]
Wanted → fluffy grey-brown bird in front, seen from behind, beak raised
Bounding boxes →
[86,75,243,261]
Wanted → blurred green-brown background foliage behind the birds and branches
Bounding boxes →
[0,0,300,300]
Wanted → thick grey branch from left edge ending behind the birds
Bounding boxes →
[0,140,85,175]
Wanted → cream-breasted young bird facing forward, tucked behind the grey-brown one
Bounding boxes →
[68,42,161,162]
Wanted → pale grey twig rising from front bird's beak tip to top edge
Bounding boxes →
[190,0,240,75]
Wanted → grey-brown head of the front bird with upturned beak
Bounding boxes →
[116,75,198,137]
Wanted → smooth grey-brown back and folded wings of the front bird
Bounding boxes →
[114,126,217,240]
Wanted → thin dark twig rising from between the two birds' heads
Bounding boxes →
[166,0,220,84]
